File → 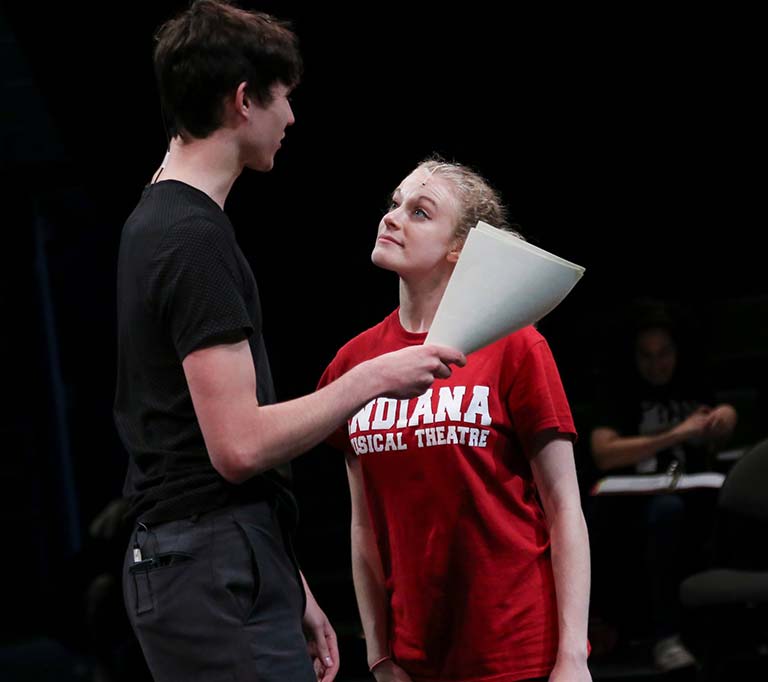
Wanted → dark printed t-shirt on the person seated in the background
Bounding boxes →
[595,378,714,474]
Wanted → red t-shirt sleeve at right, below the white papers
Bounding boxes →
[507,339,576,451]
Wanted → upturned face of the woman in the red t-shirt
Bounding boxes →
[371,169,461,278]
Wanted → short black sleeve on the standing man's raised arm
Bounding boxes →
[149,220,249,360]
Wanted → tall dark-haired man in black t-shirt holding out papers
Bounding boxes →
[115,0,464,682]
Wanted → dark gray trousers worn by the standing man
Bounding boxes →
[123,502,316,682]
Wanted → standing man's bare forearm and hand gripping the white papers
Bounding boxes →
[183,341,466,483]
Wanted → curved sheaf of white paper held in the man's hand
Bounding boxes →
[425,221,584,354]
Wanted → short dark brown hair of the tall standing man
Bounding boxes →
[154,0,302,138]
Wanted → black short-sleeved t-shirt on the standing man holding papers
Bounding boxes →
[114,180,296,522]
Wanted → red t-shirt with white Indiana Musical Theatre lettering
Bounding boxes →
[320,310,575,682]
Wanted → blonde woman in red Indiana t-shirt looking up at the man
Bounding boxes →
[320,160,591,682]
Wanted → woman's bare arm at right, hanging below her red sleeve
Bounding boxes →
[531,430,592,682]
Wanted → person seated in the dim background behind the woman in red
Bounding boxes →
[590,306,737,670]
